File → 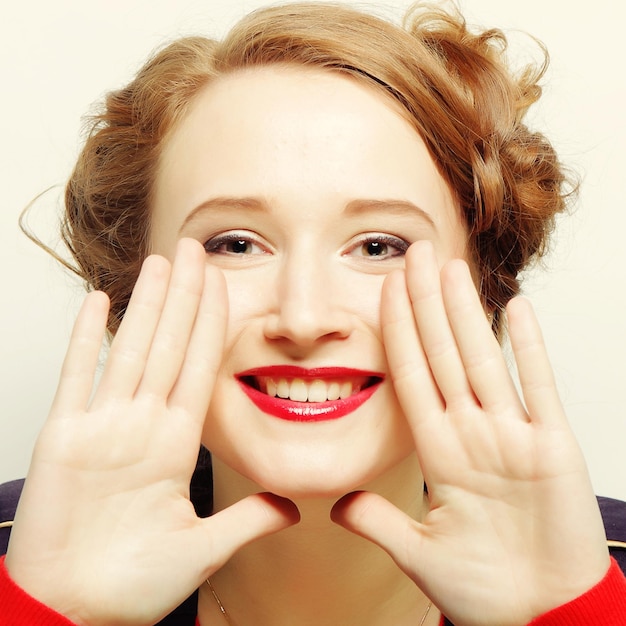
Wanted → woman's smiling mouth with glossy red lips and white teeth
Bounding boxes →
[236,365,385,422]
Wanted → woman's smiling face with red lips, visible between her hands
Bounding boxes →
[152,66,466,498]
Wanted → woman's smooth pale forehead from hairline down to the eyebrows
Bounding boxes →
[151,66,464,251]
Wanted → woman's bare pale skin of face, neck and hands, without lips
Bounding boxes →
[6,68,608,626]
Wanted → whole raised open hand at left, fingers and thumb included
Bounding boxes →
[6,240,298,626]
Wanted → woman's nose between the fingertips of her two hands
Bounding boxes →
[265,251,354,348]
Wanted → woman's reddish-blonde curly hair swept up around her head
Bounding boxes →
[54,2,573,334]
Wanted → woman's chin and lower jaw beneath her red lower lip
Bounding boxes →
[203,385,422,502]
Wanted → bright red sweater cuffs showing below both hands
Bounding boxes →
[0,557,626,626]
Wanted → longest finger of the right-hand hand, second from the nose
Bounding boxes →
[406,241,472,404]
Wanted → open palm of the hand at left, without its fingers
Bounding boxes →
[23,394,210,624]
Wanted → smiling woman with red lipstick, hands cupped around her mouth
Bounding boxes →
[0,3,626,626]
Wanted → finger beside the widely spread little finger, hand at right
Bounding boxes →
[441,259,524,415]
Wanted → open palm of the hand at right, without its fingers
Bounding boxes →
[412,400,592,625]
